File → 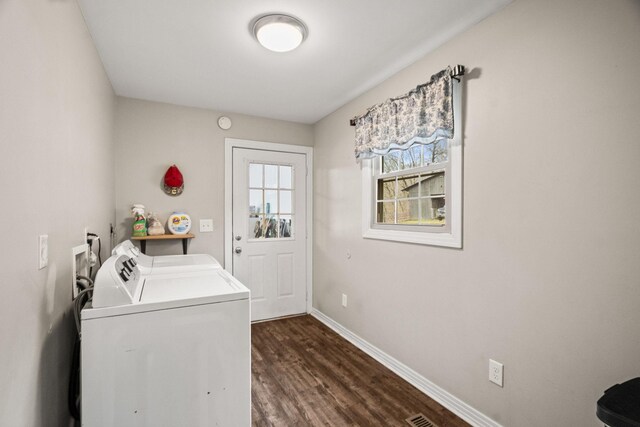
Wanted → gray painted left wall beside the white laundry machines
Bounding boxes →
[0,0,115,426]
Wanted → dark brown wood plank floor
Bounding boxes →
[251,316,468,427]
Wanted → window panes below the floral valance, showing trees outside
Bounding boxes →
[376,140,448,226]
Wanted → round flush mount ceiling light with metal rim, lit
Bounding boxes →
[253,14,307,52]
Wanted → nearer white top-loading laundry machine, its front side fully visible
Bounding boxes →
[81,255,251,427]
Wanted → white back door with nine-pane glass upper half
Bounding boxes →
[232,147,307,320]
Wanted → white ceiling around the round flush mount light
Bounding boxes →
[78,0,512,123]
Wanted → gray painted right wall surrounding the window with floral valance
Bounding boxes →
[314,0,640,427]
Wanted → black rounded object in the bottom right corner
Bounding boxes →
[596,377,640,427]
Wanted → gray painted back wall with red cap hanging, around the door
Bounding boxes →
[115,97,313,262]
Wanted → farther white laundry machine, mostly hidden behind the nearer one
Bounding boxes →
[111,240,222,275]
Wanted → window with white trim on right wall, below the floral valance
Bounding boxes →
[362,78,462,248]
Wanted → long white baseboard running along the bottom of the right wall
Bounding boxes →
[310,308,501,427]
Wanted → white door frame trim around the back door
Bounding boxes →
[224,138,313,313]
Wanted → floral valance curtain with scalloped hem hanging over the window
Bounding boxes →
[353,67,453,160]
